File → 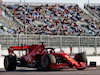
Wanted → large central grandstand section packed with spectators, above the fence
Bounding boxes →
[1,3,99,36]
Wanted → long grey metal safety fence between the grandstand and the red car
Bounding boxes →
[0,34,100,54]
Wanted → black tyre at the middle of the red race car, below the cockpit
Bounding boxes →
[41,54,56,70]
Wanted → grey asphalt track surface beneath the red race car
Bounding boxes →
[0,67,100,75]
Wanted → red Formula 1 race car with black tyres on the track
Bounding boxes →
[4,43,87,71]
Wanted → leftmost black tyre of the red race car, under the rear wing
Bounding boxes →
[4,55,16,71]
